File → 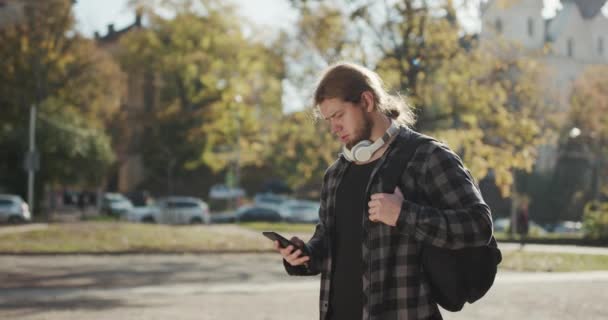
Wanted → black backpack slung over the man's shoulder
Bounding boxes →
[382,131,502,312]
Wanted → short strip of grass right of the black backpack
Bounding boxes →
[500,250,608,272]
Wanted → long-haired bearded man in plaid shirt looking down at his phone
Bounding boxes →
[275,63,492,320]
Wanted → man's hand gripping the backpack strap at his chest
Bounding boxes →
[368,187,403,227]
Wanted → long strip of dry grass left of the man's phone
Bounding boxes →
[0,222,272,253]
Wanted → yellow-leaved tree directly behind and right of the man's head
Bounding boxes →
[292,0,546,195]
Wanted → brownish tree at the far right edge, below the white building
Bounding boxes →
[553,66,608,220]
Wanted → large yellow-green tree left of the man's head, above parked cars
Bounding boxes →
[121,0,284,192]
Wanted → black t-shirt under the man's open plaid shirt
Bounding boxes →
[330,160,378,320]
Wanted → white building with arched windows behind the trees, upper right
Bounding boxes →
[480,0,608,171]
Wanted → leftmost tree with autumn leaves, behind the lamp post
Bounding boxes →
[0,0,121,214]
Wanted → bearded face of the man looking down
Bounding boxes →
[319,98,372,149]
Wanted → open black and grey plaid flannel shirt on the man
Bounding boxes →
[284,127,492,320]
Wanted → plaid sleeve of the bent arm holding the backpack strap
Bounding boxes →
[397,144,492,249]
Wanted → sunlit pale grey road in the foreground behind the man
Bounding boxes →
[0,254,608,320]
